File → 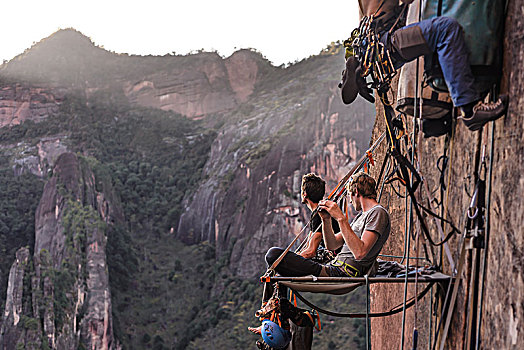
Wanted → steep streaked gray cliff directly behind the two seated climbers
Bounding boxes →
[177,51,373,277]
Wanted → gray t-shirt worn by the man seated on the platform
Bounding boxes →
[336,204,391,275]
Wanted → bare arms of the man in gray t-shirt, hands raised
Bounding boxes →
[319,201,378,260]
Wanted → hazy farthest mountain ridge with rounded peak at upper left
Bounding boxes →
[0,29,278,120]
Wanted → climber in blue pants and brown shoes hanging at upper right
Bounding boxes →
[341,0,508,130]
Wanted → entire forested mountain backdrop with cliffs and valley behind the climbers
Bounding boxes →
[0,29,374,349]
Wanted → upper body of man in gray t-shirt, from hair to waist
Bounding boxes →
[319,172,391,276]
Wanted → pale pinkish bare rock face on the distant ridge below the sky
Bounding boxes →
[124,50,269,118]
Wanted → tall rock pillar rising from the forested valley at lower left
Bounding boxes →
[1,153,117,349]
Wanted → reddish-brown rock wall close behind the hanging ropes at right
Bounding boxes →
[372,0,524,349]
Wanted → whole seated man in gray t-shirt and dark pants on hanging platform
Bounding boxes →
[266,172,390,277]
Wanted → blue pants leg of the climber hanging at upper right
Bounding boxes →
[396,17,480,107]
